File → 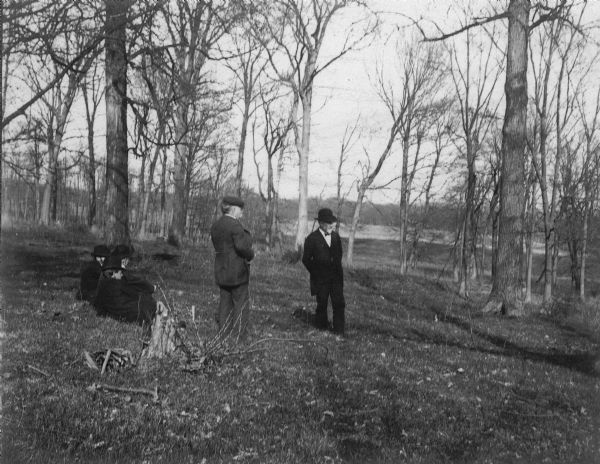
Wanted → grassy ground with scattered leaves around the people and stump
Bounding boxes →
[0,230,600,463]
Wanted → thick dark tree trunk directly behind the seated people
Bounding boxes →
[104,0,130,244]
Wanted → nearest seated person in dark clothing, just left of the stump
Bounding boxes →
[94,255,156,325]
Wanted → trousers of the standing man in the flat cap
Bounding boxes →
[216,284,250,341]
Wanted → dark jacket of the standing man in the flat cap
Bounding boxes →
[210,215,254,287]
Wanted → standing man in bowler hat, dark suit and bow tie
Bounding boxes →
[302,208,346,336]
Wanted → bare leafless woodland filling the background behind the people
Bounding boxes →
[0,0,600,313]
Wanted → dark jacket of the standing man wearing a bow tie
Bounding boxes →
[302,229,344,295]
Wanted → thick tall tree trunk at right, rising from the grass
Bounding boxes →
[488,0,531,315]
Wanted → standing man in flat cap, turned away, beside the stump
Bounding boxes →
[210,196,254,341]
